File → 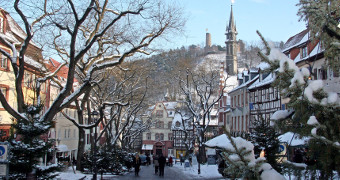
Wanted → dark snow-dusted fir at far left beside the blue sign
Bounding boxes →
[9,105,62,179]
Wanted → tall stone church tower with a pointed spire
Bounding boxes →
[225,5,238,75]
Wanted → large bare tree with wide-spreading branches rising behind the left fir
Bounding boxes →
[0,0,184,173]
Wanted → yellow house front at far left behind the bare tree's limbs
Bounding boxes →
[0,8,47,141]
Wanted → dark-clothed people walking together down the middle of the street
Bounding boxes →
[133,154,173,176]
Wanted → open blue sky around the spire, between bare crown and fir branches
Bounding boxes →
[173,0,306,48]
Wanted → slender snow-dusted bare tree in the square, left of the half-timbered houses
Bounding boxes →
[180,68,225,173]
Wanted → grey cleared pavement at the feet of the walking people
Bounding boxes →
[110,165,193,180]
